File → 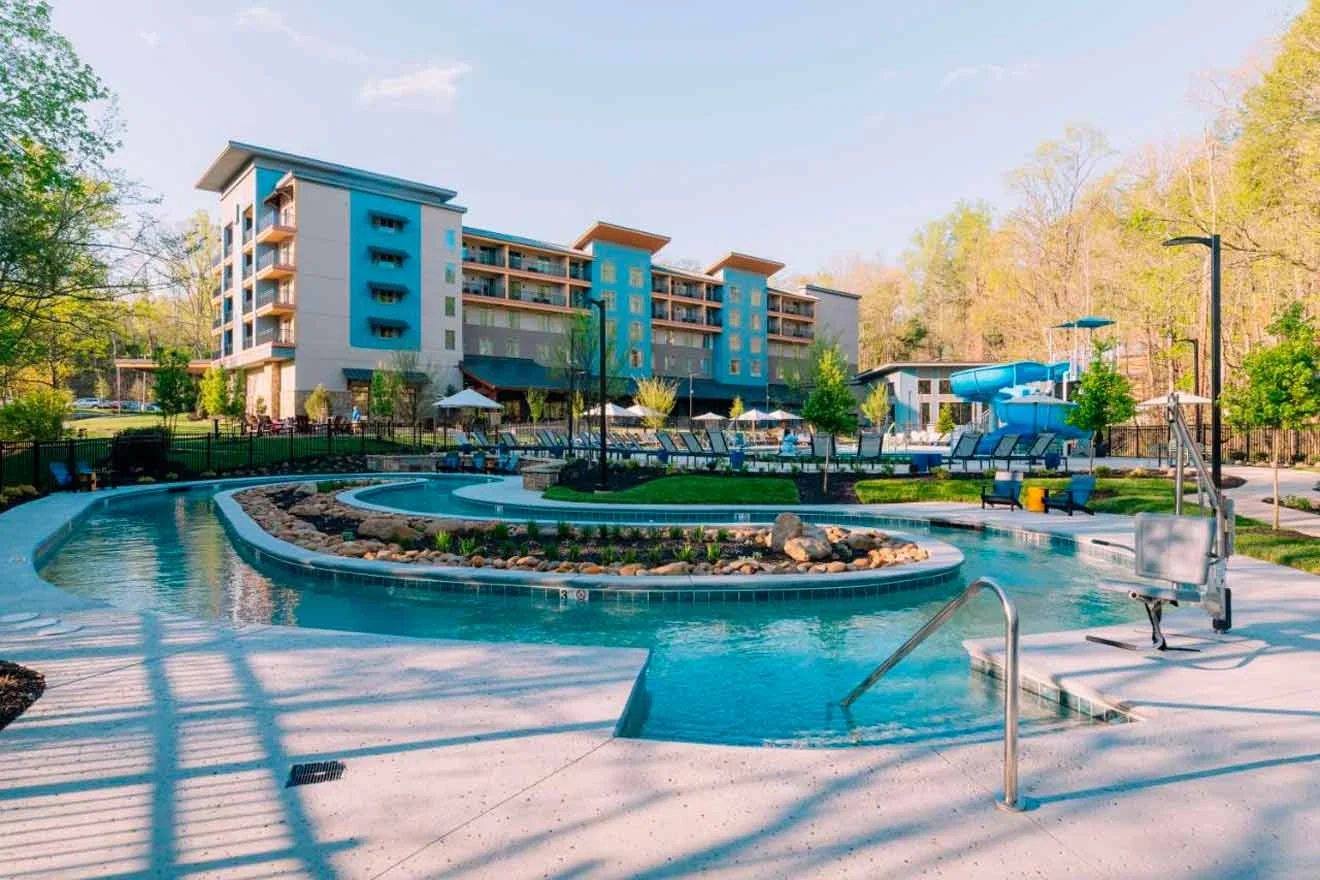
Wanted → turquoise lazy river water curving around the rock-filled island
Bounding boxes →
[41,489,1135,745]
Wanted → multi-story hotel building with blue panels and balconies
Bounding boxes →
[198,142,858,418]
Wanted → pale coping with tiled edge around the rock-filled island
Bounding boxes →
[215,478,964,602]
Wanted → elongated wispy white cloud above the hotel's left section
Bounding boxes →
[236,7,471,110]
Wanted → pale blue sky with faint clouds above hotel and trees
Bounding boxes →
[54,0,1303,272]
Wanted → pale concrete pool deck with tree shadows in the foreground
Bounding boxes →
[0,485,1320,880]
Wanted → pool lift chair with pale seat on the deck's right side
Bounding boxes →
[1086,394,1234,650]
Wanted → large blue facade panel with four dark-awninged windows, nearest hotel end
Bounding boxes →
[348,190,422,351]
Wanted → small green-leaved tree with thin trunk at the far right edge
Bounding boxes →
[1224,302,1320,529]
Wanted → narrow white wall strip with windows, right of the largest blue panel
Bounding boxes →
[418,204,463,397]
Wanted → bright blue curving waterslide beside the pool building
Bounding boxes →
[949,360,1088,451]
